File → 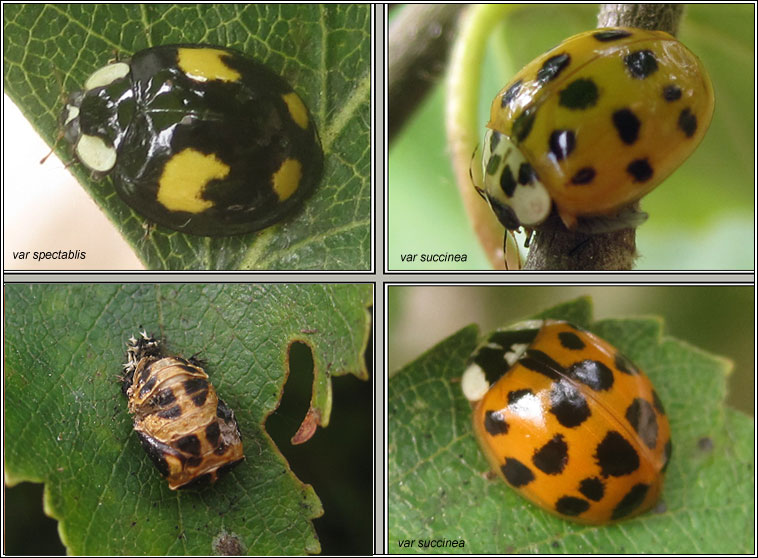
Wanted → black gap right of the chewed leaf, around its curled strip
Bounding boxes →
[266,342,374,555]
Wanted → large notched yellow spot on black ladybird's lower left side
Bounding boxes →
[158,148,229,213]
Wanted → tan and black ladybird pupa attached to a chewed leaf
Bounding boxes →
[122,332,245,490]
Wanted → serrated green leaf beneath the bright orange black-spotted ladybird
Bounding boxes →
[388,298,754,554]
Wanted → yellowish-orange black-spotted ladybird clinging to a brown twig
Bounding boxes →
[477,27,713,232]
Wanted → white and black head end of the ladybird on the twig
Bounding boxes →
[482,128,552,230]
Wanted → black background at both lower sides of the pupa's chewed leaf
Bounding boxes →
[3,343,374,556]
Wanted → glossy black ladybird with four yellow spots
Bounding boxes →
[61,45,323,236]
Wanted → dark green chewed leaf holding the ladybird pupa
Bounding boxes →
[4,284,372,555]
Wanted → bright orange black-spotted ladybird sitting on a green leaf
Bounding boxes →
[462,320,671,523]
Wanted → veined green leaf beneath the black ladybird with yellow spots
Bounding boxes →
[3,4,371,270]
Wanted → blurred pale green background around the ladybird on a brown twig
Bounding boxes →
[388,4,755,270]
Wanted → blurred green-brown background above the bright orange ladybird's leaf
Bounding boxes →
[387,285,755,416]
